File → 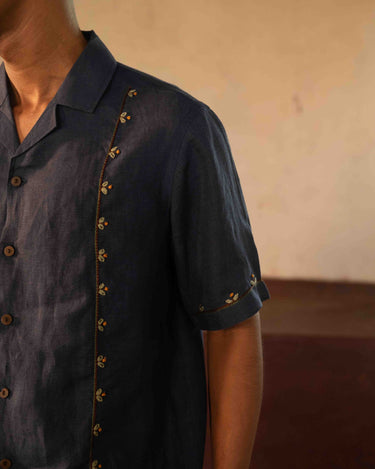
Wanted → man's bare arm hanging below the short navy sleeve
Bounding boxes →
[203,311,263,469]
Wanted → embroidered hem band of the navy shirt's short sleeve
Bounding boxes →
[193,280,271,331]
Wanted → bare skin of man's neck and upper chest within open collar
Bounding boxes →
[0,0,87,143]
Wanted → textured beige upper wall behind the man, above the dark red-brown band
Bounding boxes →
[76,0,375,281]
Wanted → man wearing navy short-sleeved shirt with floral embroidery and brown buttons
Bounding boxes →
[0,0,270,469]
